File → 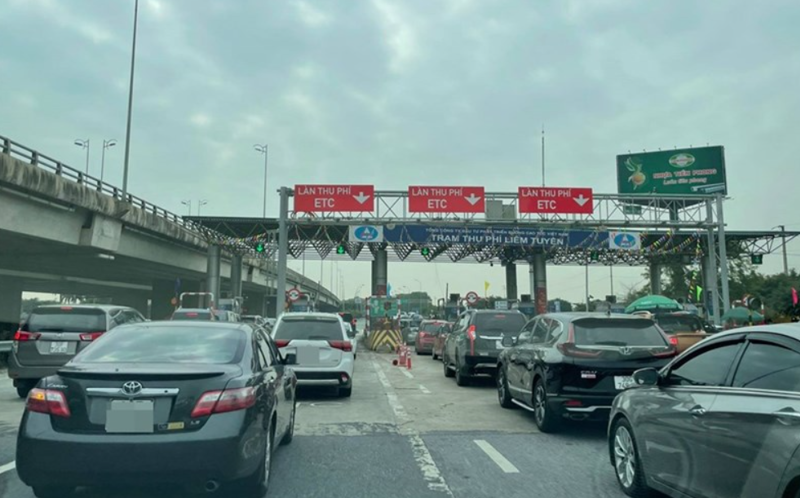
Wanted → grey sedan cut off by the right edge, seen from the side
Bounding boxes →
[608,324,800,498]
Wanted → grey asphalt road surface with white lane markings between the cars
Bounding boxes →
[0,349,624,498]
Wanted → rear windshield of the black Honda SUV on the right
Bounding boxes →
[572,319,667,346]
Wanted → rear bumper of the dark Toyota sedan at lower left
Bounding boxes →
[16,411,266,486]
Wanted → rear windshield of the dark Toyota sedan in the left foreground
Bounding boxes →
[76,324,247,364]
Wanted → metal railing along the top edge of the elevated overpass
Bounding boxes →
[0,135,203,232]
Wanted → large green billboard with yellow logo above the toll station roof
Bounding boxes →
[617,146,728,196]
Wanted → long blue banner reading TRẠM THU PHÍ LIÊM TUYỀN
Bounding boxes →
[383,225,608,249]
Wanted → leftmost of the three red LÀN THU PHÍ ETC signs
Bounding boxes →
[294,185,375,213]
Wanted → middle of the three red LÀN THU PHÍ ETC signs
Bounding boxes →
[408,187,486,213]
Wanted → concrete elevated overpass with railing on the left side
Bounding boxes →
[0,136,339,322]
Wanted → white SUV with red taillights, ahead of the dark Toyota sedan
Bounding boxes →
[272,313,355,397]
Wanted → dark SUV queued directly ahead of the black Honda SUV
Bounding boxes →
[442,310,527,386]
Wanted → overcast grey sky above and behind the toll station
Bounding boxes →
[0,0,800,301]
